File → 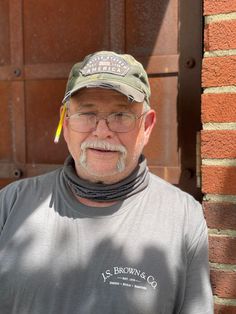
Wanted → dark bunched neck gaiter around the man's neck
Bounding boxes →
[62,155,149,202]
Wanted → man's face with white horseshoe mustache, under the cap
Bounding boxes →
[63,88,155,184]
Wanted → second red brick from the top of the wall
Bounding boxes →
[204,20,236,51]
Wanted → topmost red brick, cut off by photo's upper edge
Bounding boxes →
[204,0,236,15]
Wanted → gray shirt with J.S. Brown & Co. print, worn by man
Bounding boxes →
[0,169,213,314]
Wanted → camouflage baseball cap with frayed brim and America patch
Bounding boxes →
[62,51,151,105]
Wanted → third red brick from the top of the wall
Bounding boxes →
[202,56,236,87]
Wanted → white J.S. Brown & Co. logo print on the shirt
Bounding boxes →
[101,266,157,290]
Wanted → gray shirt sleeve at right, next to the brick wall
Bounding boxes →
[180,198,213,314]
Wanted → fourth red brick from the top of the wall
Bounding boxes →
[202,93,236,123]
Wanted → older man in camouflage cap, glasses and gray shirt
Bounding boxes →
[0,51,213,314]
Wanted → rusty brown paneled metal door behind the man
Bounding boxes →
[0,0,202,197]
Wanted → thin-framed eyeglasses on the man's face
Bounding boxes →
[66,111,147,133]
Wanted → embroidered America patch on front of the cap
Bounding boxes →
[80,54,130,76]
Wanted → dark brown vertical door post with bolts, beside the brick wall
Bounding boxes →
[177,0,203,200]
